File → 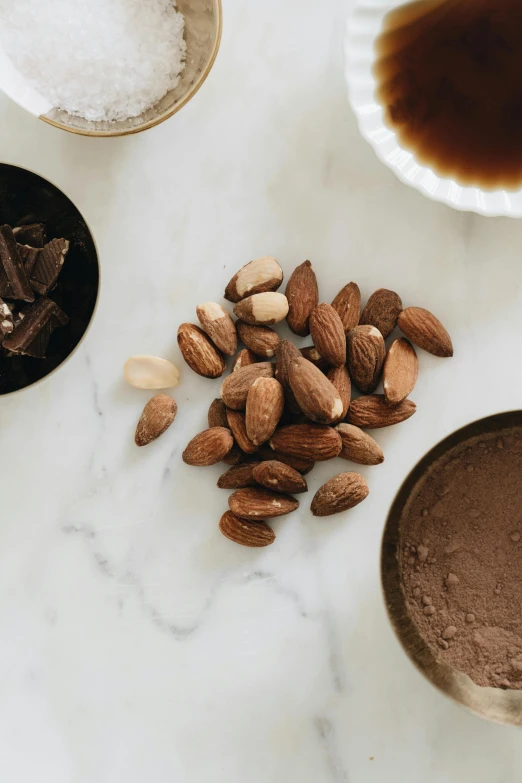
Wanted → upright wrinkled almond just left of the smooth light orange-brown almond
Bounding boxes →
[346,326,386,394]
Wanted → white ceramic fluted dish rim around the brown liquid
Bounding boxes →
[344,0,522,217]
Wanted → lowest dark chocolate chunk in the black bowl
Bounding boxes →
[2,297,69,359]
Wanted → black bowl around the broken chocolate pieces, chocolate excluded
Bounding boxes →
[0,163,99,394]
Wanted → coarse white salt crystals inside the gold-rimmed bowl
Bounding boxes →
[0,0,186,121]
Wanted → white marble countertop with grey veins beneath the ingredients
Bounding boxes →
[0,0,522,783]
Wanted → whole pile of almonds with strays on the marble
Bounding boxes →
[126,257,453,547]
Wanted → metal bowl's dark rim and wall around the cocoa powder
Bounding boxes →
[381,411,522,726]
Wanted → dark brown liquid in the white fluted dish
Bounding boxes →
[374,0,522,189]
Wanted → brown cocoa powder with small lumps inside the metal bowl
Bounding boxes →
[399,427,522,689]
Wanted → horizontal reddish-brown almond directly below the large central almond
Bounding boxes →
[270,424,342,462]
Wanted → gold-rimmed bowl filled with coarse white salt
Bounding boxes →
[0,0,222,136]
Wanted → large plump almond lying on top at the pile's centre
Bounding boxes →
[289,356,343,424]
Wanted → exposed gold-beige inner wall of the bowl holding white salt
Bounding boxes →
[41,0,221,136]
